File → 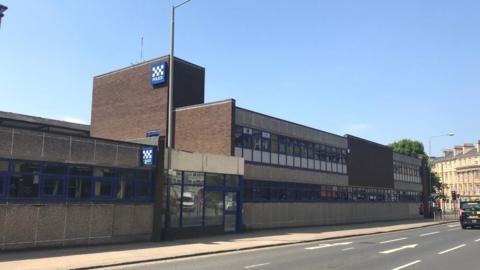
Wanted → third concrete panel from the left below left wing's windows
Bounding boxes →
[65,204,91,239]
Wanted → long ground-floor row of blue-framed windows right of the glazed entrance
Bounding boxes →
[244,180,422,202]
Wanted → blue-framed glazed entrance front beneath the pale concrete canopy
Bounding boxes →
[166,171,240,232]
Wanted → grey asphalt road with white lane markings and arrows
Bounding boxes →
[101,223,480,270]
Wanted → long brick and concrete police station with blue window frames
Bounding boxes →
[0,56,426,250]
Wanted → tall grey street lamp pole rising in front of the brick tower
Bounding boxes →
[167,0,191,170]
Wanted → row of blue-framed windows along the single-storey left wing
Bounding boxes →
[0,160,153,201]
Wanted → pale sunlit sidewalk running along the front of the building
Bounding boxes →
[0,220,450,270]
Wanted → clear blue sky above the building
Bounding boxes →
[0,0,480,155]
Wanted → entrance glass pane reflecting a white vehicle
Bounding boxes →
[182,186,203,227]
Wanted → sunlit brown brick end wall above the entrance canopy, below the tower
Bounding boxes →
[174,100,235,156]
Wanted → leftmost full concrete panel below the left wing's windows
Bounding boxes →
[5,204,37,244]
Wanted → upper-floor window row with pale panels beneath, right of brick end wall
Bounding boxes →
[235,126,347,174]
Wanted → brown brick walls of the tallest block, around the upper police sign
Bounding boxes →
[91,56,205,140]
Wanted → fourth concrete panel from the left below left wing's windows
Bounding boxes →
[90,204,114,237]
